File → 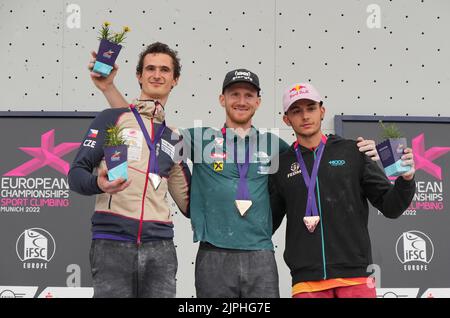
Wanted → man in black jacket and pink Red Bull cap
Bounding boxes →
[269,83,415,298]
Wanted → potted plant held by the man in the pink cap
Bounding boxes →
[376,120,411,177]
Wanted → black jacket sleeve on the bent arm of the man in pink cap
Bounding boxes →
[361,154,416,218]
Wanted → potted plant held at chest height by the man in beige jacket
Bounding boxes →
[103,125,128,181]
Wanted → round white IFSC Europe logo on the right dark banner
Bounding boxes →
[395,231,434,271]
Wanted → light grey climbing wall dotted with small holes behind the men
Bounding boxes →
[0,0,450,297]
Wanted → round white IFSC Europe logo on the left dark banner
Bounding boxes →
[16,228,56,269]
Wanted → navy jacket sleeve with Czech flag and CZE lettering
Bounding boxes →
[68,111,115,195]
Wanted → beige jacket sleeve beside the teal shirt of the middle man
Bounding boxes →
[168,137,191,218]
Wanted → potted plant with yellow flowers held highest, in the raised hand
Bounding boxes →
[93,22,130,77]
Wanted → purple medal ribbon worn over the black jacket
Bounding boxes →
[295,141,325,216]
